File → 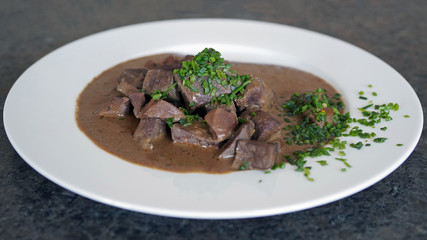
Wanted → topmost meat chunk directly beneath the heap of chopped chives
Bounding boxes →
[174,74,231,108]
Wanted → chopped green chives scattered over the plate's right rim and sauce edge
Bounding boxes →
[266,85,403,181]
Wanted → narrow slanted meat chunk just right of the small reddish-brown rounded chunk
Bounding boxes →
[219,120,255,158]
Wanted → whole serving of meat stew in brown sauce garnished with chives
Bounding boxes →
[76,48,348,173]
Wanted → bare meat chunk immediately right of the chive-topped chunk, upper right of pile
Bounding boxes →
[235,77,277,111]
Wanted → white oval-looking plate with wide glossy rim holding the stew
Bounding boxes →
[4,19,423,219]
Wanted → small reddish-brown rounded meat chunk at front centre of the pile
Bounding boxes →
[205,108,238,142]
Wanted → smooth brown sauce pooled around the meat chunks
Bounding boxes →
[76,54,336,173]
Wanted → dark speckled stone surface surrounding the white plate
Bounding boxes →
[0,0,427,239]
